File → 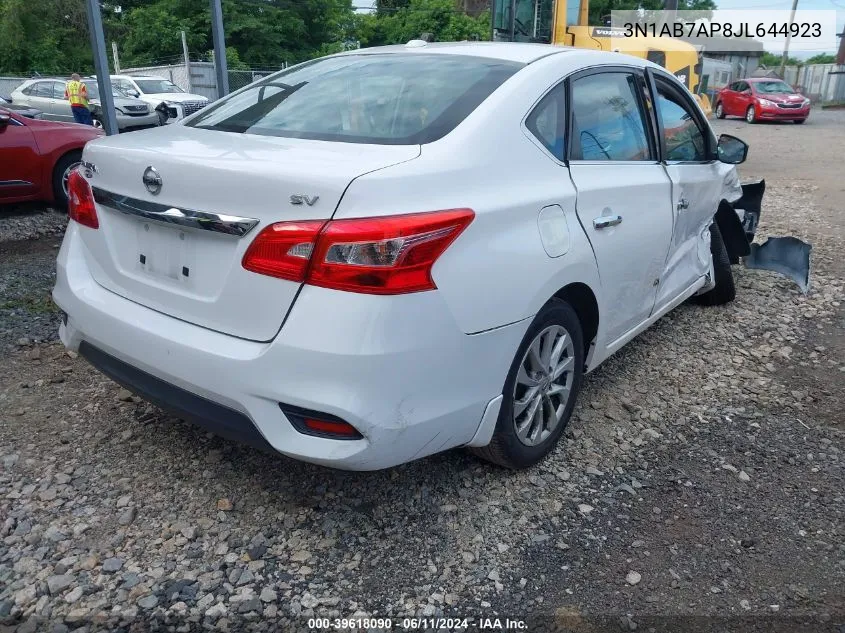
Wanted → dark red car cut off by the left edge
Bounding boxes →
[0,107,103,207]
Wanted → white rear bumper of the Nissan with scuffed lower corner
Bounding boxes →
[53,222,528,470]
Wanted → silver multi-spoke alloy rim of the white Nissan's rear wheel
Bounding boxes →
[513,325,575,446]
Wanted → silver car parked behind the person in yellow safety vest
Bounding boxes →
[11,79,159,131]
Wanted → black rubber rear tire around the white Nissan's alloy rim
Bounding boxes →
[470,299,584,469]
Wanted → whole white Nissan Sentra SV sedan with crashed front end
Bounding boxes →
[53,42,760,470]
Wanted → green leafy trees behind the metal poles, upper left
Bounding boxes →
[0,0,488,74]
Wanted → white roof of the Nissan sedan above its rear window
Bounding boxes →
[332,40,576,64]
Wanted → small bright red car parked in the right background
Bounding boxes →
[713,77,810,123]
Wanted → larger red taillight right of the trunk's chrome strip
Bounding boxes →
[243,209,475,295]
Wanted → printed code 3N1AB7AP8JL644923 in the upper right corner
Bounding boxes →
[619,22,822,38]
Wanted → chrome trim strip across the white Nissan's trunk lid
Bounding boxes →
[92,187,258,237]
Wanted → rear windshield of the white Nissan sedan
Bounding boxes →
[186,53,523,145]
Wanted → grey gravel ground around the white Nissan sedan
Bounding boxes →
[0,112,845,633]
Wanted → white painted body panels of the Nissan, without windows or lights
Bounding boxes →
[54,44,739,470]
